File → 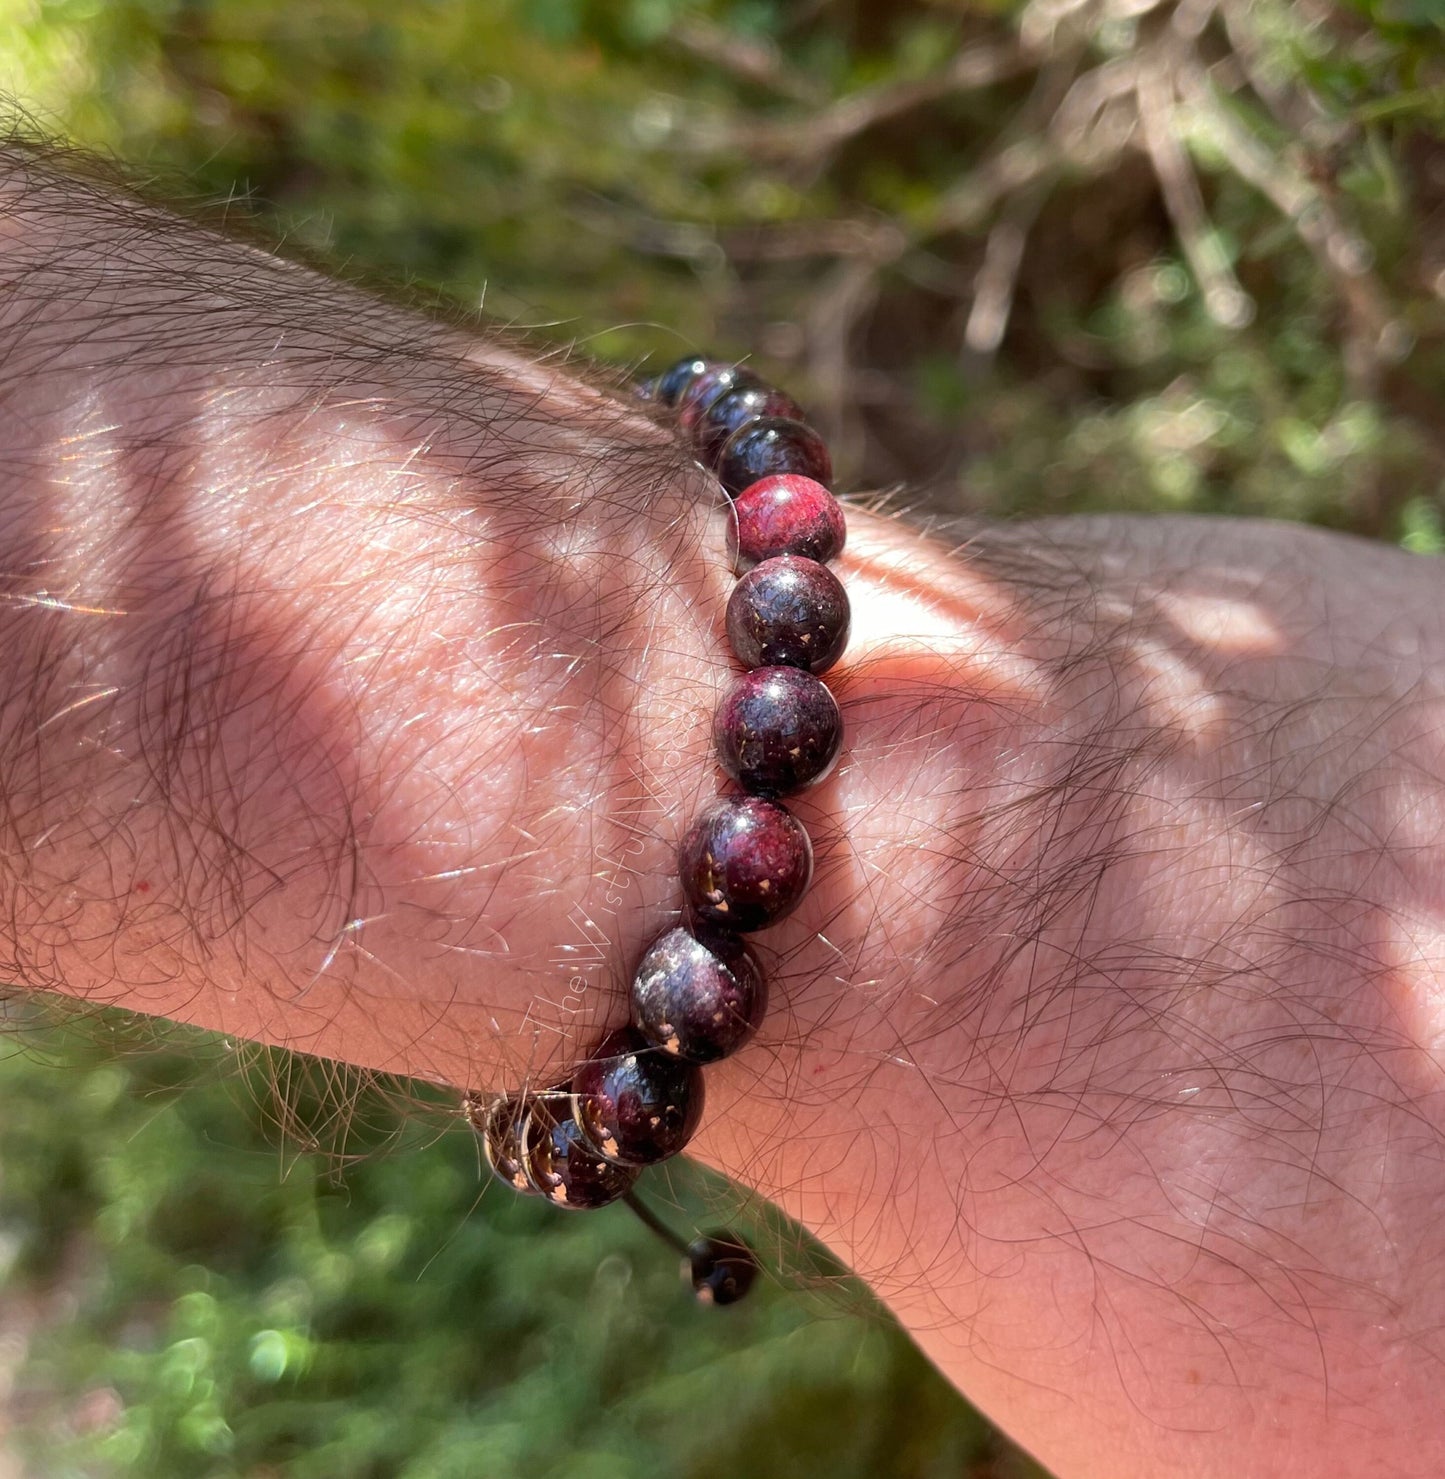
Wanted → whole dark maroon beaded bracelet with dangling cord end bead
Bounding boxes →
[463,356,849,1304]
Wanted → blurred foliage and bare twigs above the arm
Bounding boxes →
[0,0,1445,535]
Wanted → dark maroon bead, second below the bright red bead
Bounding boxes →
[713,667,843,798]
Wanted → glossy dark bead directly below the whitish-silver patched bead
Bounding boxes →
[572,1028,703,1165]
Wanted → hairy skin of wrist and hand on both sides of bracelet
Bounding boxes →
[0,155,1445,1479]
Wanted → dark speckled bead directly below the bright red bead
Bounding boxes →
[728,555,849,673]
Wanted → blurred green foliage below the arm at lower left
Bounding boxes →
[0,1028,989,1479]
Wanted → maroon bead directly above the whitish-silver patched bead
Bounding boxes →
[677,796,813,932]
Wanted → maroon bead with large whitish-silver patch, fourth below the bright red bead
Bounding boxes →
[632,929,768,1063]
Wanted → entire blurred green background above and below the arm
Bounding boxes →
[0,0,1445,1479]
